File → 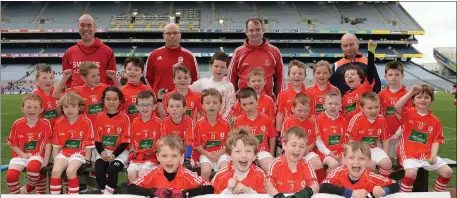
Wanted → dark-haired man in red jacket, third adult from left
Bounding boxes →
[227,18,284,98]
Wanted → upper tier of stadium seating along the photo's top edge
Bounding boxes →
[2,2,421,31]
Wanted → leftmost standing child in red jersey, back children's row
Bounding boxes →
[33,64,59,127]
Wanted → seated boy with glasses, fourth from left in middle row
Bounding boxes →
[127,91,162,182]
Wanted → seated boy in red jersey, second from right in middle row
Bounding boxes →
[347,92,392,178]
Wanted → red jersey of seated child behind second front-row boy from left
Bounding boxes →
[233,112,276,152]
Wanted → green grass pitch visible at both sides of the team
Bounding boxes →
[0,94,456,194]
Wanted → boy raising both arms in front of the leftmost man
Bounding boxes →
[52,62,121,123]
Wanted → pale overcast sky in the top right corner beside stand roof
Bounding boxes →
[400,2,457,63]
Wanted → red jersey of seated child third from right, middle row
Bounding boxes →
[315,112,348,156]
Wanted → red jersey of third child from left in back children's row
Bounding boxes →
[120,82,156,121]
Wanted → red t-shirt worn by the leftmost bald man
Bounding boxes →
[62,38,116,87]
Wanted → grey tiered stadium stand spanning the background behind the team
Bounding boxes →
[1,1,455,194]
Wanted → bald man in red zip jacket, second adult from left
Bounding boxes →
[144,23,198,94]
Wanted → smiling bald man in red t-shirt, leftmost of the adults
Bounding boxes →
[62,14,116,88]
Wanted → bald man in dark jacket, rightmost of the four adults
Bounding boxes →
[330,33,381,95]
